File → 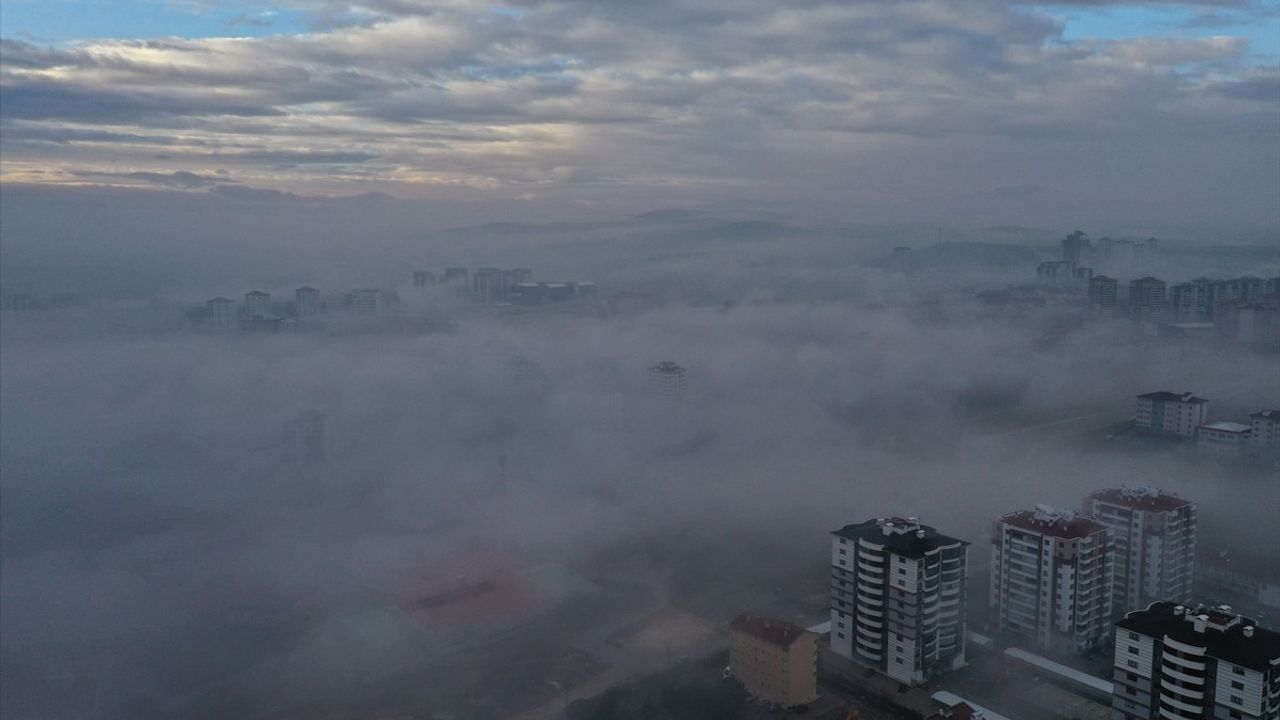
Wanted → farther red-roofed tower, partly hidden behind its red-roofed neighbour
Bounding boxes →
[1084,486,1196,616]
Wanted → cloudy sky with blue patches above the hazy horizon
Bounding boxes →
[0,0,1280,228]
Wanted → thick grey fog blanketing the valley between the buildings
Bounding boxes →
[0,214,1280,717]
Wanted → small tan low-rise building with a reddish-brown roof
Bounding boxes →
[728,612,818,707]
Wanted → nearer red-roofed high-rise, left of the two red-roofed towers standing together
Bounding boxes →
[991,505,1112,655]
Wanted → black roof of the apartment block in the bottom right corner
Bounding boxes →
[1116,602,1280,673]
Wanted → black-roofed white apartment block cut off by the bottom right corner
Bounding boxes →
[1111,602,1280,720]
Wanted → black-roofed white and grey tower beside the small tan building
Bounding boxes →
[831,518,969,685]
